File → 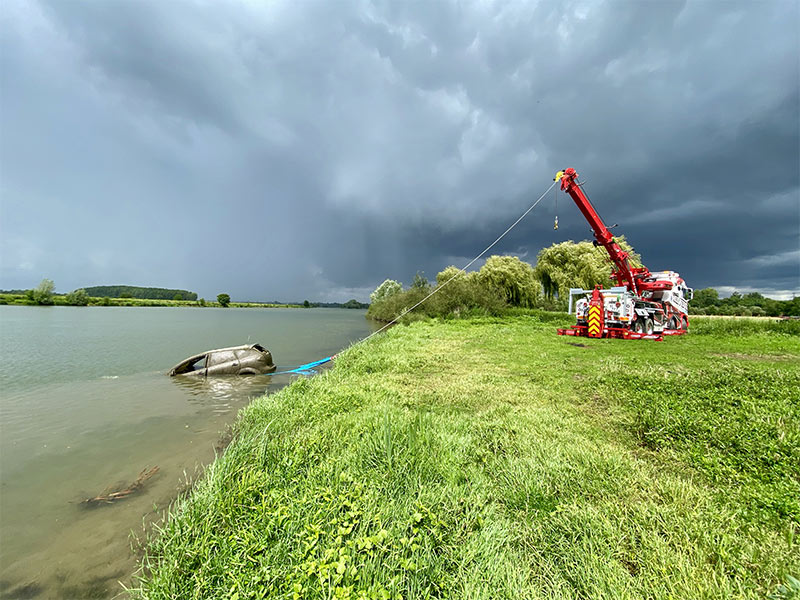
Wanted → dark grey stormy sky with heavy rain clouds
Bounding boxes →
[0,0,800,301]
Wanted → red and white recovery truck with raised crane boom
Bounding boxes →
[555,168,693,341]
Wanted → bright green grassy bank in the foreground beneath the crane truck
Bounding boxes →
[134,315,800,600]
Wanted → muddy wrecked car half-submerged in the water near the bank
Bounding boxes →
[169,344,277,377]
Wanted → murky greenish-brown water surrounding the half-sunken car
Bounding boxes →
[0,306,376,598]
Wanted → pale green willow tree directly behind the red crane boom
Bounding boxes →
[534,236,642,306]
